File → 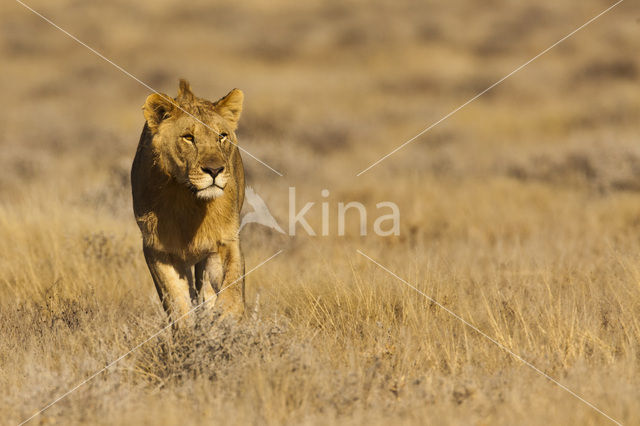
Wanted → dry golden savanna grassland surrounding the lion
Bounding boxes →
[0,0,640,425]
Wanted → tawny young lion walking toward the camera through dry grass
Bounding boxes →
[131,80,245,324]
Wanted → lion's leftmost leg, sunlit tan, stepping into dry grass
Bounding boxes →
[144,248,194,327]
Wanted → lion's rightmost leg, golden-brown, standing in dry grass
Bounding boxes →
[215,241,244,319]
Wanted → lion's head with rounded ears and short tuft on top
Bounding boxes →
[143,80,243,200]
